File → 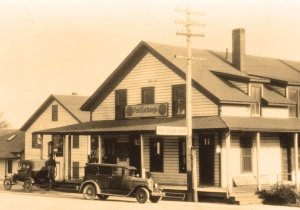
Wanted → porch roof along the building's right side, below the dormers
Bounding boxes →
[222,117,300,132]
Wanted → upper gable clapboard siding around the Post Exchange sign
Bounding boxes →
[92,53,218,120]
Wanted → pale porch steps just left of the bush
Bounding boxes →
[229,186,263,205]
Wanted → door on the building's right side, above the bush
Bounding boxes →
[280,135,292,181]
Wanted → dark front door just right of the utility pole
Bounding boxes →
[199,134,215,186]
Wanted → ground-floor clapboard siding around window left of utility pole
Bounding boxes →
[144,136,199,185]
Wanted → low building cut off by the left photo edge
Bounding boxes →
[0,129,24,179]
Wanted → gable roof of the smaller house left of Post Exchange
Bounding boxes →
[20,95,90,131]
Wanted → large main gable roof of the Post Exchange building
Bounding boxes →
[81,41,300,111]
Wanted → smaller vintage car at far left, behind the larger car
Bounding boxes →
[3,160,49,192]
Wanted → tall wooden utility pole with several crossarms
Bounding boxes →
[175,7,204,202]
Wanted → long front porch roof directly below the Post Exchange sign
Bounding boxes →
[34,116,227,134]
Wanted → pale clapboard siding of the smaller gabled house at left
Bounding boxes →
[25,101,78,159]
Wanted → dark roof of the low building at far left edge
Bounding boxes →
[0,129,25,158]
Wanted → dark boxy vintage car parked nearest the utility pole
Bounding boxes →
[80,163,163,203]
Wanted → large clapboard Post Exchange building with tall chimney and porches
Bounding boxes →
[37,29,300,197]
